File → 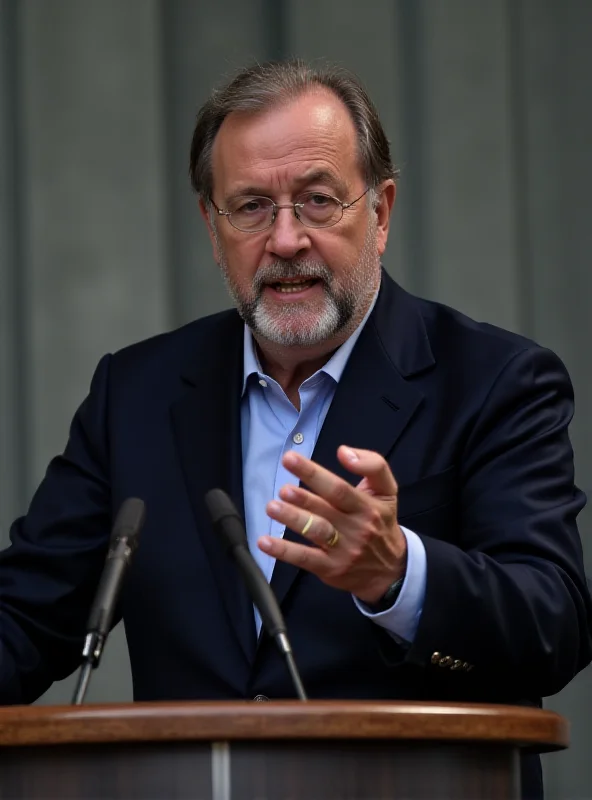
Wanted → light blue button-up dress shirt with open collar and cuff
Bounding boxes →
[241,298,426,642]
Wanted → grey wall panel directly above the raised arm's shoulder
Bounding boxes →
[419,0,520,330]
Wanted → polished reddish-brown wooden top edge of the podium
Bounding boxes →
[0,700,569,752]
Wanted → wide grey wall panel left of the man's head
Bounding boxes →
[18,0,167,702]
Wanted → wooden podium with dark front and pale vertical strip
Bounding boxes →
[0,701,569,800]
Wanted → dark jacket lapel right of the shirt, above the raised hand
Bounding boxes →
[271,273,434,603]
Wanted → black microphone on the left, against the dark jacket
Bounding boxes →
[72,497,146,705]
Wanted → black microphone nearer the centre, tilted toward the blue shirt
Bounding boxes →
[205,489,308,700]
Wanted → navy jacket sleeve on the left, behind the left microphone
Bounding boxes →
[0,356,111,704]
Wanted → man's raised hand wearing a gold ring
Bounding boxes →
[258,445,407,604]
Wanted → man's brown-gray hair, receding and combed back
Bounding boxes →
[189,60,399,202]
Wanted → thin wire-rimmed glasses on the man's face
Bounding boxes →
[210,187,370,233]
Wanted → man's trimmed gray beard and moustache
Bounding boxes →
[214,222,380,347]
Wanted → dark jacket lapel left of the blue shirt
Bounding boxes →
[171,314,256,664]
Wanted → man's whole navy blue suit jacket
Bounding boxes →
[0,274,591,792]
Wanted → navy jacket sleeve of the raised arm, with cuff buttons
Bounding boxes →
[406,347,592,698]
